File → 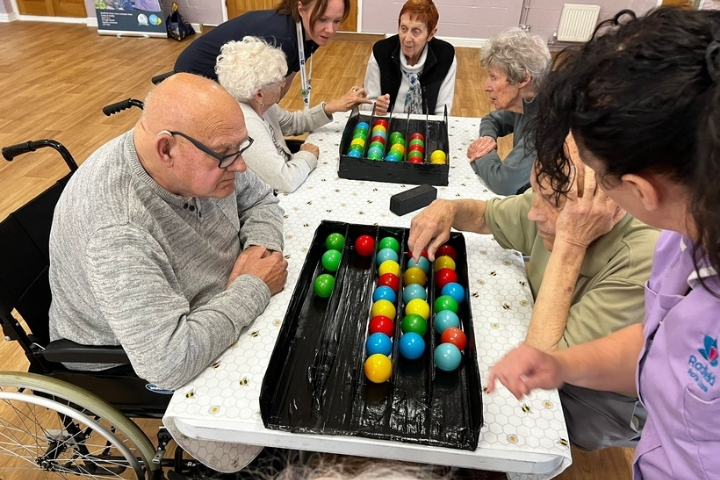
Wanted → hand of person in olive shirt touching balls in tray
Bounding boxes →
[408,199,455,262]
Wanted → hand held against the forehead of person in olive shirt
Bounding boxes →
[555,164,626,248]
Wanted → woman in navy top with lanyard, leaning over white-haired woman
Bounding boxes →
[175,0,350,101]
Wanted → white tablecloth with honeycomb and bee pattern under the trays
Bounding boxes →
[163,110,572,479]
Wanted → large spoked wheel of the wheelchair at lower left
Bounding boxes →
[0,372,160,480]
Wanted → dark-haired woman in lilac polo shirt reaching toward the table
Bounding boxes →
[488,9,720,480]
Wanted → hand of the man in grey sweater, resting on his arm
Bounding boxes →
[225,245,287,295]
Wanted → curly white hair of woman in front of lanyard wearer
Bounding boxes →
[215,36,287,103]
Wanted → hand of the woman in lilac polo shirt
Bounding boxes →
[487,344,563,400]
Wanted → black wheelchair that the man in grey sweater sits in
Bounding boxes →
[0,125,221,480]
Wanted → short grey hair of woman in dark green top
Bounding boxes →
[480,27,550,92]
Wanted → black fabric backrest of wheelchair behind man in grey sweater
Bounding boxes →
[0,174,72,346]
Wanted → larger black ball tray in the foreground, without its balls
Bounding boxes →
[260,221,482,450]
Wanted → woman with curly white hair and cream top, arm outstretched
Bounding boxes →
[215,37,370,193]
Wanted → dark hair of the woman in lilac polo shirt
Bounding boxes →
[528,8,720,296]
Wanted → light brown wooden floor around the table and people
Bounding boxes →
[0,22,632,480]
